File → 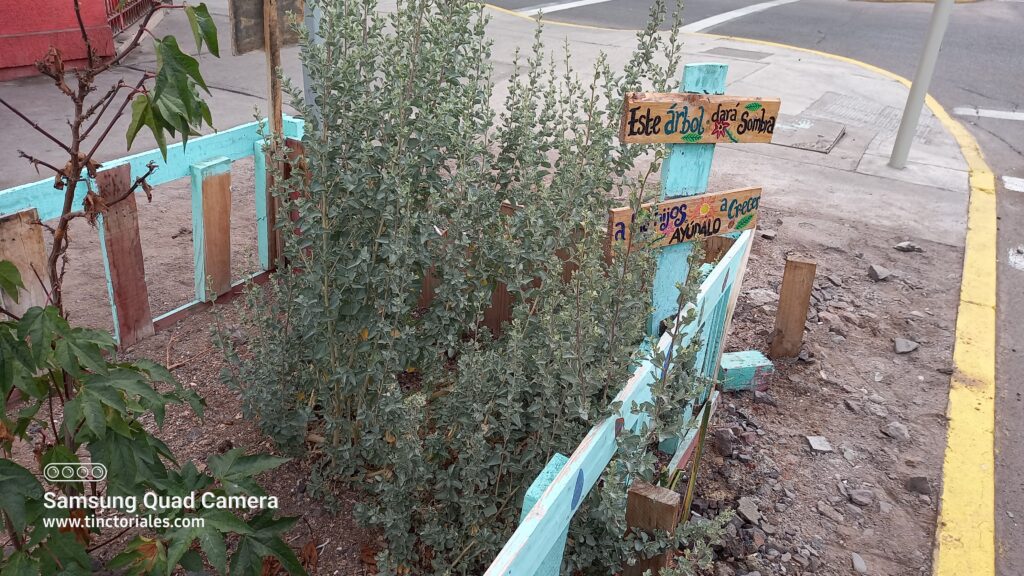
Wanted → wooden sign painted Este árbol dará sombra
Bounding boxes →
[618,92,781,143]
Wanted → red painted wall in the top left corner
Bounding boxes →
[0,0,114,80]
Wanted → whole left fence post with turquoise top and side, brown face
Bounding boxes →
[191,157,231,302]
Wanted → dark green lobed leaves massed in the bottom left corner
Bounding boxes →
[0,261,304,575]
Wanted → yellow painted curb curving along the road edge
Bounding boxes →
[485,4,996,576]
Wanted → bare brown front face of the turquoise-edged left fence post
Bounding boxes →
[203,163,231,296]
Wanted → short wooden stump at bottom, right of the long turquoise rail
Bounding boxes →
[623,479,683,576]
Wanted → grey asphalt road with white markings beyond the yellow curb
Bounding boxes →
[485,0,1024,576]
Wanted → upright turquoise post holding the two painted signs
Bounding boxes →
[648,64,729,334]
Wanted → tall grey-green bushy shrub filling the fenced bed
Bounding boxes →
[222,0,729,574]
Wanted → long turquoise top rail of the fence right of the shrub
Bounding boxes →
[485,231,753,576]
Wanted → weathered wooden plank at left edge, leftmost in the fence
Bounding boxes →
[0,209,50,313]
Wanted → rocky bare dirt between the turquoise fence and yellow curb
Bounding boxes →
[693,203,961,576]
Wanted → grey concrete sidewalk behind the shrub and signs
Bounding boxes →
[0,0,968,246]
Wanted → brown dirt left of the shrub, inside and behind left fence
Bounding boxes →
[29,159,379,576]
